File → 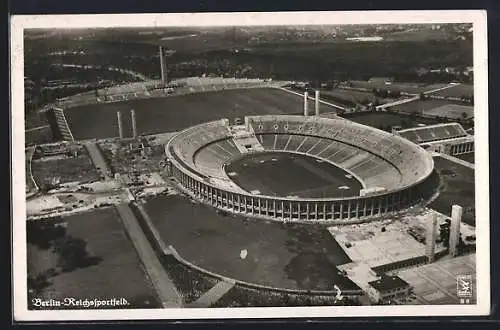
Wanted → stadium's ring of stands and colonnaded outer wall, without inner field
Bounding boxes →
[165,115,438,223]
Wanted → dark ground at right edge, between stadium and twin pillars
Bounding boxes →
[430,157,475,226]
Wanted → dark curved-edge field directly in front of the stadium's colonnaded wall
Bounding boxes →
[145,195,357,290]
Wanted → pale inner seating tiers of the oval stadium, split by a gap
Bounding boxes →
[169,116,434,190]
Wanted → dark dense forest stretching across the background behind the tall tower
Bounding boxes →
[25,36,473,109]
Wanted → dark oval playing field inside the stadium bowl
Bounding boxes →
[226,152,362,198]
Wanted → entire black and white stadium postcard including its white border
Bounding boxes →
[11,10,490,320]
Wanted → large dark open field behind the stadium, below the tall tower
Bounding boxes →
[66,88,334,139]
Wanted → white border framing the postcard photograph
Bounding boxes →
[10,10,490,321]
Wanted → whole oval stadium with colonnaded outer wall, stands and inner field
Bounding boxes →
[165,115,437,222]
